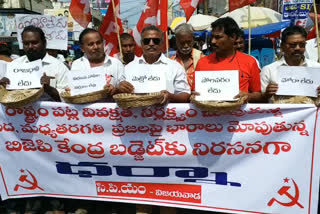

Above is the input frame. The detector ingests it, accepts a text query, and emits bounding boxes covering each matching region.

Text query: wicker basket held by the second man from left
[60,89,109,104]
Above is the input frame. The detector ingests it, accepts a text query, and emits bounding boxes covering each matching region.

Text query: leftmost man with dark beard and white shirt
[0,26,68,101]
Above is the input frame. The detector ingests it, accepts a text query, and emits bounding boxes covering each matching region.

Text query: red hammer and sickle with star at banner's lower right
[268,178,304,209]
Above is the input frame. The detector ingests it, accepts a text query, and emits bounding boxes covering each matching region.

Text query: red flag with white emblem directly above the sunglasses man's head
[132,0,168,56]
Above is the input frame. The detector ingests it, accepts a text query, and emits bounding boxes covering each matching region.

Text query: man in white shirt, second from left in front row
[71,28,124,95]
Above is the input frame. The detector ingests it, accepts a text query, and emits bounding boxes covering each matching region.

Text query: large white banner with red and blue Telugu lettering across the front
[0,102,320,214]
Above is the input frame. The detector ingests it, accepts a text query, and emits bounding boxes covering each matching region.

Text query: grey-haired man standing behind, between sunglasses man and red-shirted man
[170,23,204,87]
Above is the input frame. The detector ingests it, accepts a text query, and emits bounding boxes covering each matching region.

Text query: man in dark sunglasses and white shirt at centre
[118,25,190,104]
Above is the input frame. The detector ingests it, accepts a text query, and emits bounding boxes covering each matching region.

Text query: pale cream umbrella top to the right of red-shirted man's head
[221,6,282,28]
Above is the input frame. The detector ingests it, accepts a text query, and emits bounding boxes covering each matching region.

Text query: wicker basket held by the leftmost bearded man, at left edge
[0,86,44,108]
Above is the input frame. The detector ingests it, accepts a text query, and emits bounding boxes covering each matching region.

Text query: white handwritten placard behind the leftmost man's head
[15,14,68,50]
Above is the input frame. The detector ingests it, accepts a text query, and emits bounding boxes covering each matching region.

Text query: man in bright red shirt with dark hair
[192,17,261,102]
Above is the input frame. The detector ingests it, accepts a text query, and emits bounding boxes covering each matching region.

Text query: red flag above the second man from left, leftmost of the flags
[69,0,91,28]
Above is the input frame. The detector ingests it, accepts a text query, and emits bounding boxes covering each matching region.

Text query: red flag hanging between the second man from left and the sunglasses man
[99,0,123,56]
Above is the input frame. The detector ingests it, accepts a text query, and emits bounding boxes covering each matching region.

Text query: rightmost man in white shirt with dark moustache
[261,26,320,102]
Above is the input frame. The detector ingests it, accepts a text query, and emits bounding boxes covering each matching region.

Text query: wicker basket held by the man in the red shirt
[190,95,245,113]
